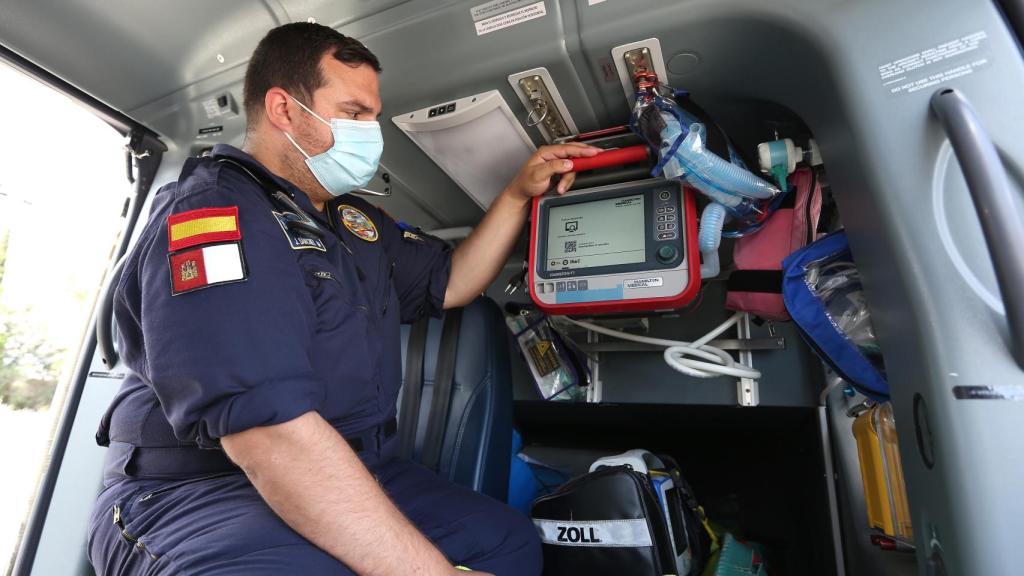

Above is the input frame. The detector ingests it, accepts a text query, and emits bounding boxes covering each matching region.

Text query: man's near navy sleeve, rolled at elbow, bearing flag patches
[138,184,325,447]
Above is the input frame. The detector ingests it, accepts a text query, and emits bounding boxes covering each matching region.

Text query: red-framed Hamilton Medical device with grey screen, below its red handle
[529,178,700,314]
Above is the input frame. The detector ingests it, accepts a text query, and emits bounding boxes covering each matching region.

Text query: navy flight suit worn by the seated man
[88,146,541,576]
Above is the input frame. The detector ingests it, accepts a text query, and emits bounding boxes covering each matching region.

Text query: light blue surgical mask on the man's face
[285,92,384,196]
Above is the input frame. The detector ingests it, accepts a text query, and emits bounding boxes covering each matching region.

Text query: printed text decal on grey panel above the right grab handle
[879,30,991,95]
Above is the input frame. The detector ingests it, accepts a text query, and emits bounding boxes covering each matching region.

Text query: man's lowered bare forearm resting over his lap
[221,412,453,575]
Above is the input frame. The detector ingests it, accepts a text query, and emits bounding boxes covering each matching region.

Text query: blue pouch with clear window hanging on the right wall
[782,231,889,402]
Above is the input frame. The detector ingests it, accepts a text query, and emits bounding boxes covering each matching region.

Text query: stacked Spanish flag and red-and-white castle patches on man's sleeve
[167,206,248,296]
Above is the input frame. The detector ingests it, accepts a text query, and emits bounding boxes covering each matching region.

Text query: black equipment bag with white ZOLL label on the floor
[530,450,702,576]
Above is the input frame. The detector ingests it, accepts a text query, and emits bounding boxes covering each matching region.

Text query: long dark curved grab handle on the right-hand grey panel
[932,88,1024,368]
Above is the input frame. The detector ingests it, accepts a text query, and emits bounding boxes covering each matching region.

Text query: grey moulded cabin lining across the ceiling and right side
[8,0,1024,574]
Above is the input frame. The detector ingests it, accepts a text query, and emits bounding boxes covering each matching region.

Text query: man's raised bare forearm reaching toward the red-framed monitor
[444,191,529,308]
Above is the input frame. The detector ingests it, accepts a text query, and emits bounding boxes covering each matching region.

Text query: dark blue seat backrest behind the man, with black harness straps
[398,297,512,501]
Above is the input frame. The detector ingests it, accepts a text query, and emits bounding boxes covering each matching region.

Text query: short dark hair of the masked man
[244,22,381,126]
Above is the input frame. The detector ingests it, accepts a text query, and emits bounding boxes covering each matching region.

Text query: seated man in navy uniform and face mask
[89,24,597,576]
